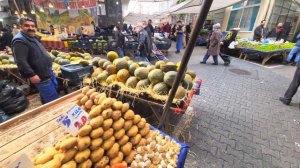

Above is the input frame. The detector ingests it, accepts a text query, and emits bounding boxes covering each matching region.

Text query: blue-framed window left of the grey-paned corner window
[227,0,261,31]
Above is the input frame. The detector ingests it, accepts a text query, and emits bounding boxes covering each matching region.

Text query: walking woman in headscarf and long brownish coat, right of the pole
[200,23,222,65]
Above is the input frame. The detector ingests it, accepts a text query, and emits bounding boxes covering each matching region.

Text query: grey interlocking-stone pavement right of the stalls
[166,47,300,168]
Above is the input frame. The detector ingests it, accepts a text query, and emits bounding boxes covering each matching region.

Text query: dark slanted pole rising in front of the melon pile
[158,0,213,128]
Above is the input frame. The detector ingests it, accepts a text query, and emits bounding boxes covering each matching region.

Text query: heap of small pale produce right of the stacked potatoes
[131,131,181,168]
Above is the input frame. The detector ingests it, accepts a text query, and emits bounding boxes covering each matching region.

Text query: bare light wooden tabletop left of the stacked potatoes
[0,90,81,168]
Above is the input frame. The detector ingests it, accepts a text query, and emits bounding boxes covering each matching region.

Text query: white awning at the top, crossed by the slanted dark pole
[170,0,241,14]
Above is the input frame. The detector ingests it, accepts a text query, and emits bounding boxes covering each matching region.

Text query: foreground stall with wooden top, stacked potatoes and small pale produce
[0,87,189,168]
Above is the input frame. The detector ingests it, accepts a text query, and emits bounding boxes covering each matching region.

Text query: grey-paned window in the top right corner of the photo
[268,0,300,34]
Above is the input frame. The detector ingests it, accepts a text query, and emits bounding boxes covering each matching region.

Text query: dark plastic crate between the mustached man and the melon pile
[60,64,94,85]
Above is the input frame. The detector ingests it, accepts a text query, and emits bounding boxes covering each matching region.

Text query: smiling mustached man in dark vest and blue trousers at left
[12,17,58,103]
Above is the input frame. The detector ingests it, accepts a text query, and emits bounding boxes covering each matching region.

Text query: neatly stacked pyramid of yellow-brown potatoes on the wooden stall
[34,87,150,168]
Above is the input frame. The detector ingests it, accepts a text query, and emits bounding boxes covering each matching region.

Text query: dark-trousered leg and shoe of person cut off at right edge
[279,61,300,108]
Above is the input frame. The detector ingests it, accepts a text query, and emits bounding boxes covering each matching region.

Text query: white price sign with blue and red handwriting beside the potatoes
[57,105,89,136]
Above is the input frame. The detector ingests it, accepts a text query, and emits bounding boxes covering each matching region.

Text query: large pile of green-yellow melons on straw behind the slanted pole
[91,51,196,99]
